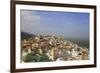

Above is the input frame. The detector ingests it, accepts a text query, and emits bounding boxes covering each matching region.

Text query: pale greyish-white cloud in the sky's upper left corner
[21,10,41,32]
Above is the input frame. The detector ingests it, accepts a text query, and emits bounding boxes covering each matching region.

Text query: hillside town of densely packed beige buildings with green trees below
[21,35,90,63]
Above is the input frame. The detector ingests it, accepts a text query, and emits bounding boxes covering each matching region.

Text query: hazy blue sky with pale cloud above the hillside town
[21,10,89,38]
